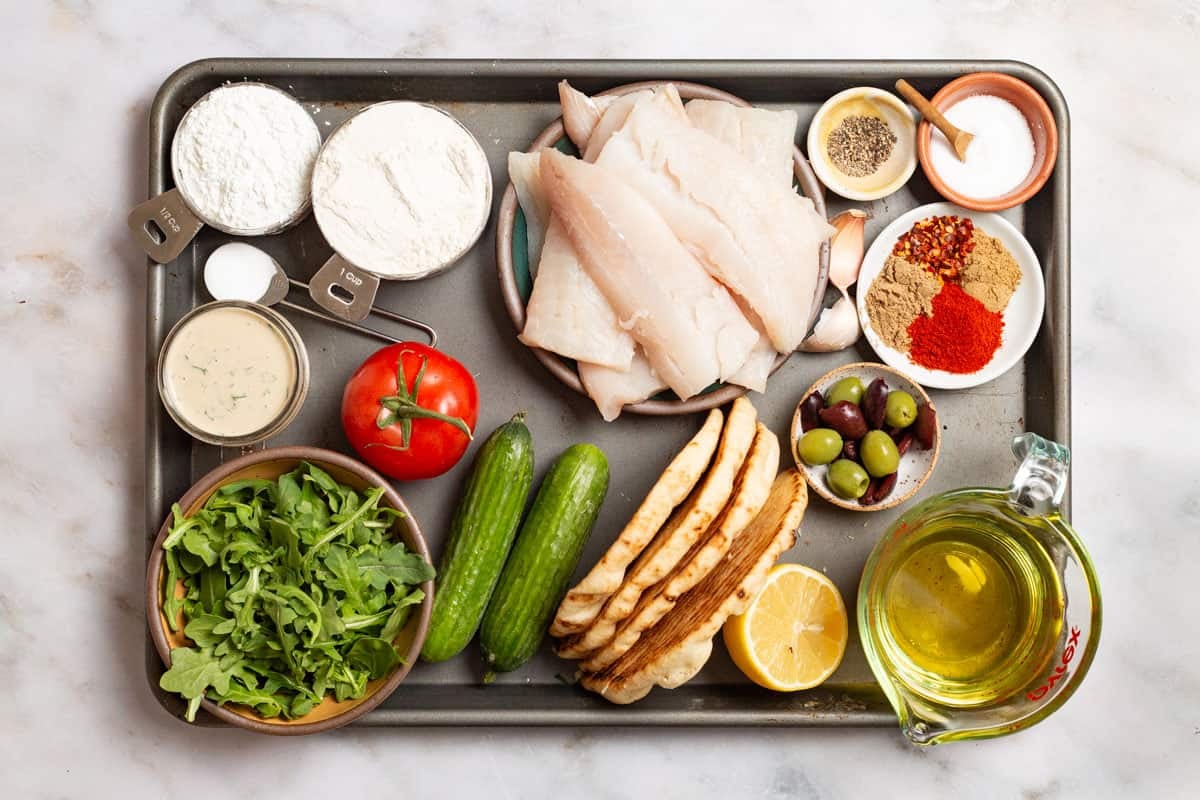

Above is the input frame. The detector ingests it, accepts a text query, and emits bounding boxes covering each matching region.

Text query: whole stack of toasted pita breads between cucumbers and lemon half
[550,398,808,703]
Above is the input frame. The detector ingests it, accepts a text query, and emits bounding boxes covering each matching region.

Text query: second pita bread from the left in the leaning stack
[558,397,758,658]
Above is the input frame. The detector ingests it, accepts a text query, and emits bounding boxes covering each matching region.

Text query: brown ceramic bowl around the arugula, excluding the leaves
[146,447,433,736]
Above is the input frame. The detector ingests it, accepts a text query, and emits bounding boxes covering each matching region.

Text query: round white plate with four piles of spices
[858,203,1045,389]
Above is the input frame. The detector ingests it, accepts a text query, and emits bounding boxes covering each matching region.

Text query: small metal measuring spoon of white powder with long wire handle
[204,242,438,347]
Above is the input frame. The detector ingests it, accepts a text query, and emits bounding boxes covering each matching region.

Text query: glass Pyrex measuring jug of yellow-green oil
[858,433,1100,745]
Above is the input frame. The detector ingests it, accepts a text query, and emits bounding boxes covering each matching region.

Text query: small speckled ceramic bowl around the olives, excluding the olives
[790,361,942,511]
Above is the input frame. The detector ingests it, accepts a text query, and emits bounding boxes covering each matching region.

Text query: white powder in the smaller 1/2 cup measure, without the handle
[172,84,320,233]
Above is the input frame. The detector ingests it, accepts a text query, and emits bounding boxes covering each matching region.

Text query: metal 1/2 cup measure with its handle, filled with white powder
[128,82,320,264]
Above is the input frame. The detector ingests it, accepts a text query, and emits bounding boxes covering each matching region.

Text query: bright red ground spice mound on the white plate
[908,283,1004,373]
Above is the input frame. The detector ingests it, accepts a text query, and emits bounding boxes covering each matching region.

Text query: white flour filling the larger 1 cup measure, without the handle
[312,102,491,278]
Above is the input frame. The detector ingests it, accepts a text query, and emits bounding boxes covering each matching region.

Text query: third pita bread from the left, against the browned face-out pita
[580,422,779,672]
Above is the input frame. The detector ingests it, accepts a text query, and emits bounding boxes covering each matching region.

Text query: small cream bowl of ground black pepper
[808,86,917,200]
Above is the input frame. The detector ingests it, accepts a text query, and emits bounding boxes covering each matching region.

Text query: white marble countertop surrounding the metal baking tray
[0,0,1200,799]
